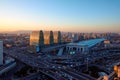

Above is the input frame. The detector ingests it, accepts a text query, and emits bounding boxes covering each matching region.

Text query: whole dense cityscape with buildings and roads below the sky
[0,31,120,80]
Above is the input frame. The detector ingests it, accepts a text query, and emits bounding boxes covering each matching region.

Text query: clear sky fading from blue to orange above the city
[0,0,120,32]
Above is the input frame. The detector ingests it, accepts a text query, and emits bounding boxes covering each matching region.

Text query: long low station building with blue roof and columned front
[66,38,105,54]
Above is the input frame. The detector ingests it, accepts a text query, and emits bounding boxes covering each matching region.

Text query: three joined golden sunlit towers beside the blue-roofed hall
[30,30,61,52]
